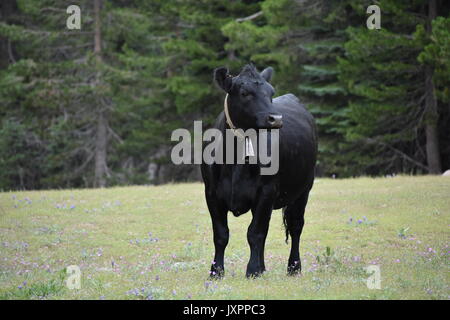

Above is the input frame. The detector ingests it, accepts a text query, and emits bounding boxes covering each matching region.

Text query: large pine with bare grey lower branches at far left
[0,0,170,188]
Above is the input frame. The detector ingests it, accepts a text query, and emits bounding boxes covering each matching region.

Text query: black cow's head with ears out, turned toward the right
[214,65,283,130]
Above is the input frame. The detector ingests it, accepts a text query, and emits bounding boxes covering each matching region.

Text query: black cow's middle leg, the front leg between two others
[246,185,274,278]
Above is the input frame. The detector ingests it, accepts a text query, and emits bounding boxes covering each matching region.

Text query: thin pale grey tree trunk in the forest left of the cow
[94,0,108,188]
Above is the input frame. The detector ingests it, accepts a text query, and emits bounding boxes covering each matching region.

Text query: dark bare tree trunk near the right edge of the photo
[425,0,442,174]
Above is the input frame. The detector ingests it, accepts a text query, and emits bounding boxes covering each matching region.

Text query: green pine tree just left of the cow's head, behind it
[122,0,268,183]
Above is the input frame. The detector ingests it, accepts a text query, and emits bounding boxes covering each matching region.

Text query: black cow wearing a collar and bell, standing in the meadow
[201,65,317,278]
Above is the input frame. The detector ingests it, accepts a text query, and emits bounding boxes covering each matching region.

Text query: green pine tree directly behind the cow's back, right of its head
[222,0,362,176]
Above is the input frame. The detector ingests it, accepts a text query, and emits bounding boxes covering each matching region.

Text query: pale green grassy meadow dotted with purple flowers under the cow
[0,176,450,299]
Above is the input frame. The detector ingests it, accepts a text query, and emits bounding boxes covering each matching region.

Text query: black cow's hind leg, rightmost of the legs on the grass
[283,190,309,275]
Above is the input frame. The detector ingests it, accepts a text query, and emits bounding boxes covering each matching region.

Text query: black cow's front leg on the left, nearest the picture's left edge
[206,191,230,279]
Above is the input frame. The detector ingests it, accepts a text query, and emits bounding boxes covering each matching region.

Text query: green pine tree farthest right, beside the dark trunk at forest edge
[339,0,448,174]
